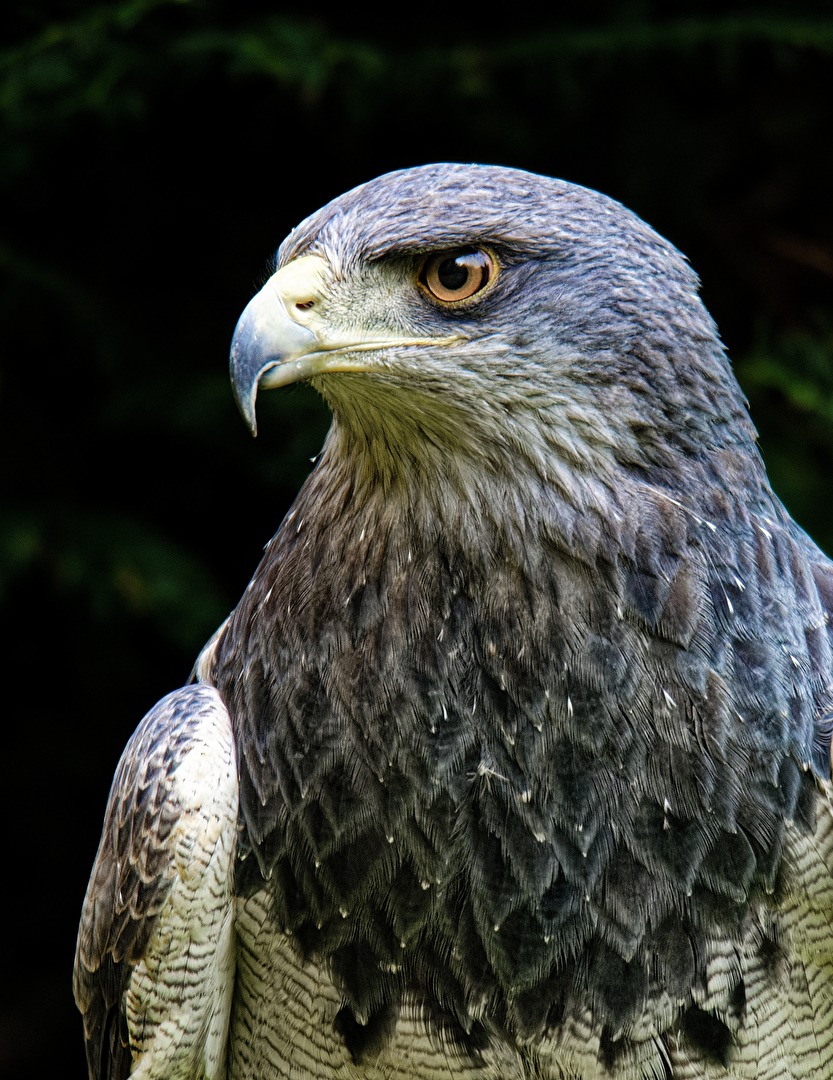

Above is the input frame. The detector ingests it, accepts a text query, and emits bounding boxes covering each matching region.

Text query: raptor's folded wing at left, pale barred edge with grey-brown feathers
[73,685,238,1080]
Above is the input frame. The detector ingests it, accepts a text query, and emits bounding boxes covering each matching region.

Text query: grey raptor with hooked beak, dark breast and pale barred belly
[75,164,833,1080]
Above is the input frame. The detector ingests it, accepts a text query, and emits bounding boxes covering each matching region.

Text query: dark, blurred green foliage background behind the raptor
[0,0,833,1080]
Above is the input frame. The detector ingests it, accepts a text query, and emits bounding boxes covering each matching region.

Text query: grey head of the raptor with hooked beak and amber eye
[231,164,755,494]
